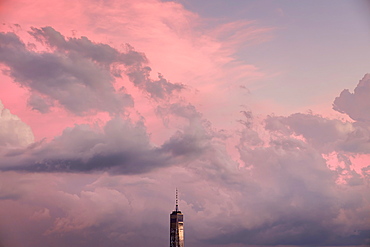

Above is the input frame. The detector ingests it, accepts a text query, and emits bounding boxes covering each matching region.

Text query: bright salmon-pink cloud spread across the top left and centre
[4,0,270,143]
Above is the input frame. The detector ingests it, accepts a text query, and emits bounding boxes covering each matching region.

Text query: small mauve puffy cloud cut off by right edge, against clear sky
[333,74,370,122]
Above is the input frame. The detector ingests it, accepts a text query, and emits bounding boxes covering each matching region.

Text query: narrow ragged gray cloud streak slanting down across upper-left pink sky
[30,27,185,99]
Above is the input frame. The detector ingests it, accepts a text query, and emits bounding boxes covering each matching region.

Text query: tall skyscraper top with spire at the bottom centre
[170,189,184,247]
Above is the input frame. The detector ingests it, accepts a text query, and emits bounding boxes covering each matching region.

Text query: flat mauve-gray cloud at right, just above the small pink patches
[265,113,370,153]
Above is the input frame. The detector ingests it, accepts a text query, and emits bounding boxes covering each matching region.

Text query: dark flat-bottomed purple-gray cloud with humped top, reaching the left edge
[1,106,212,174]
